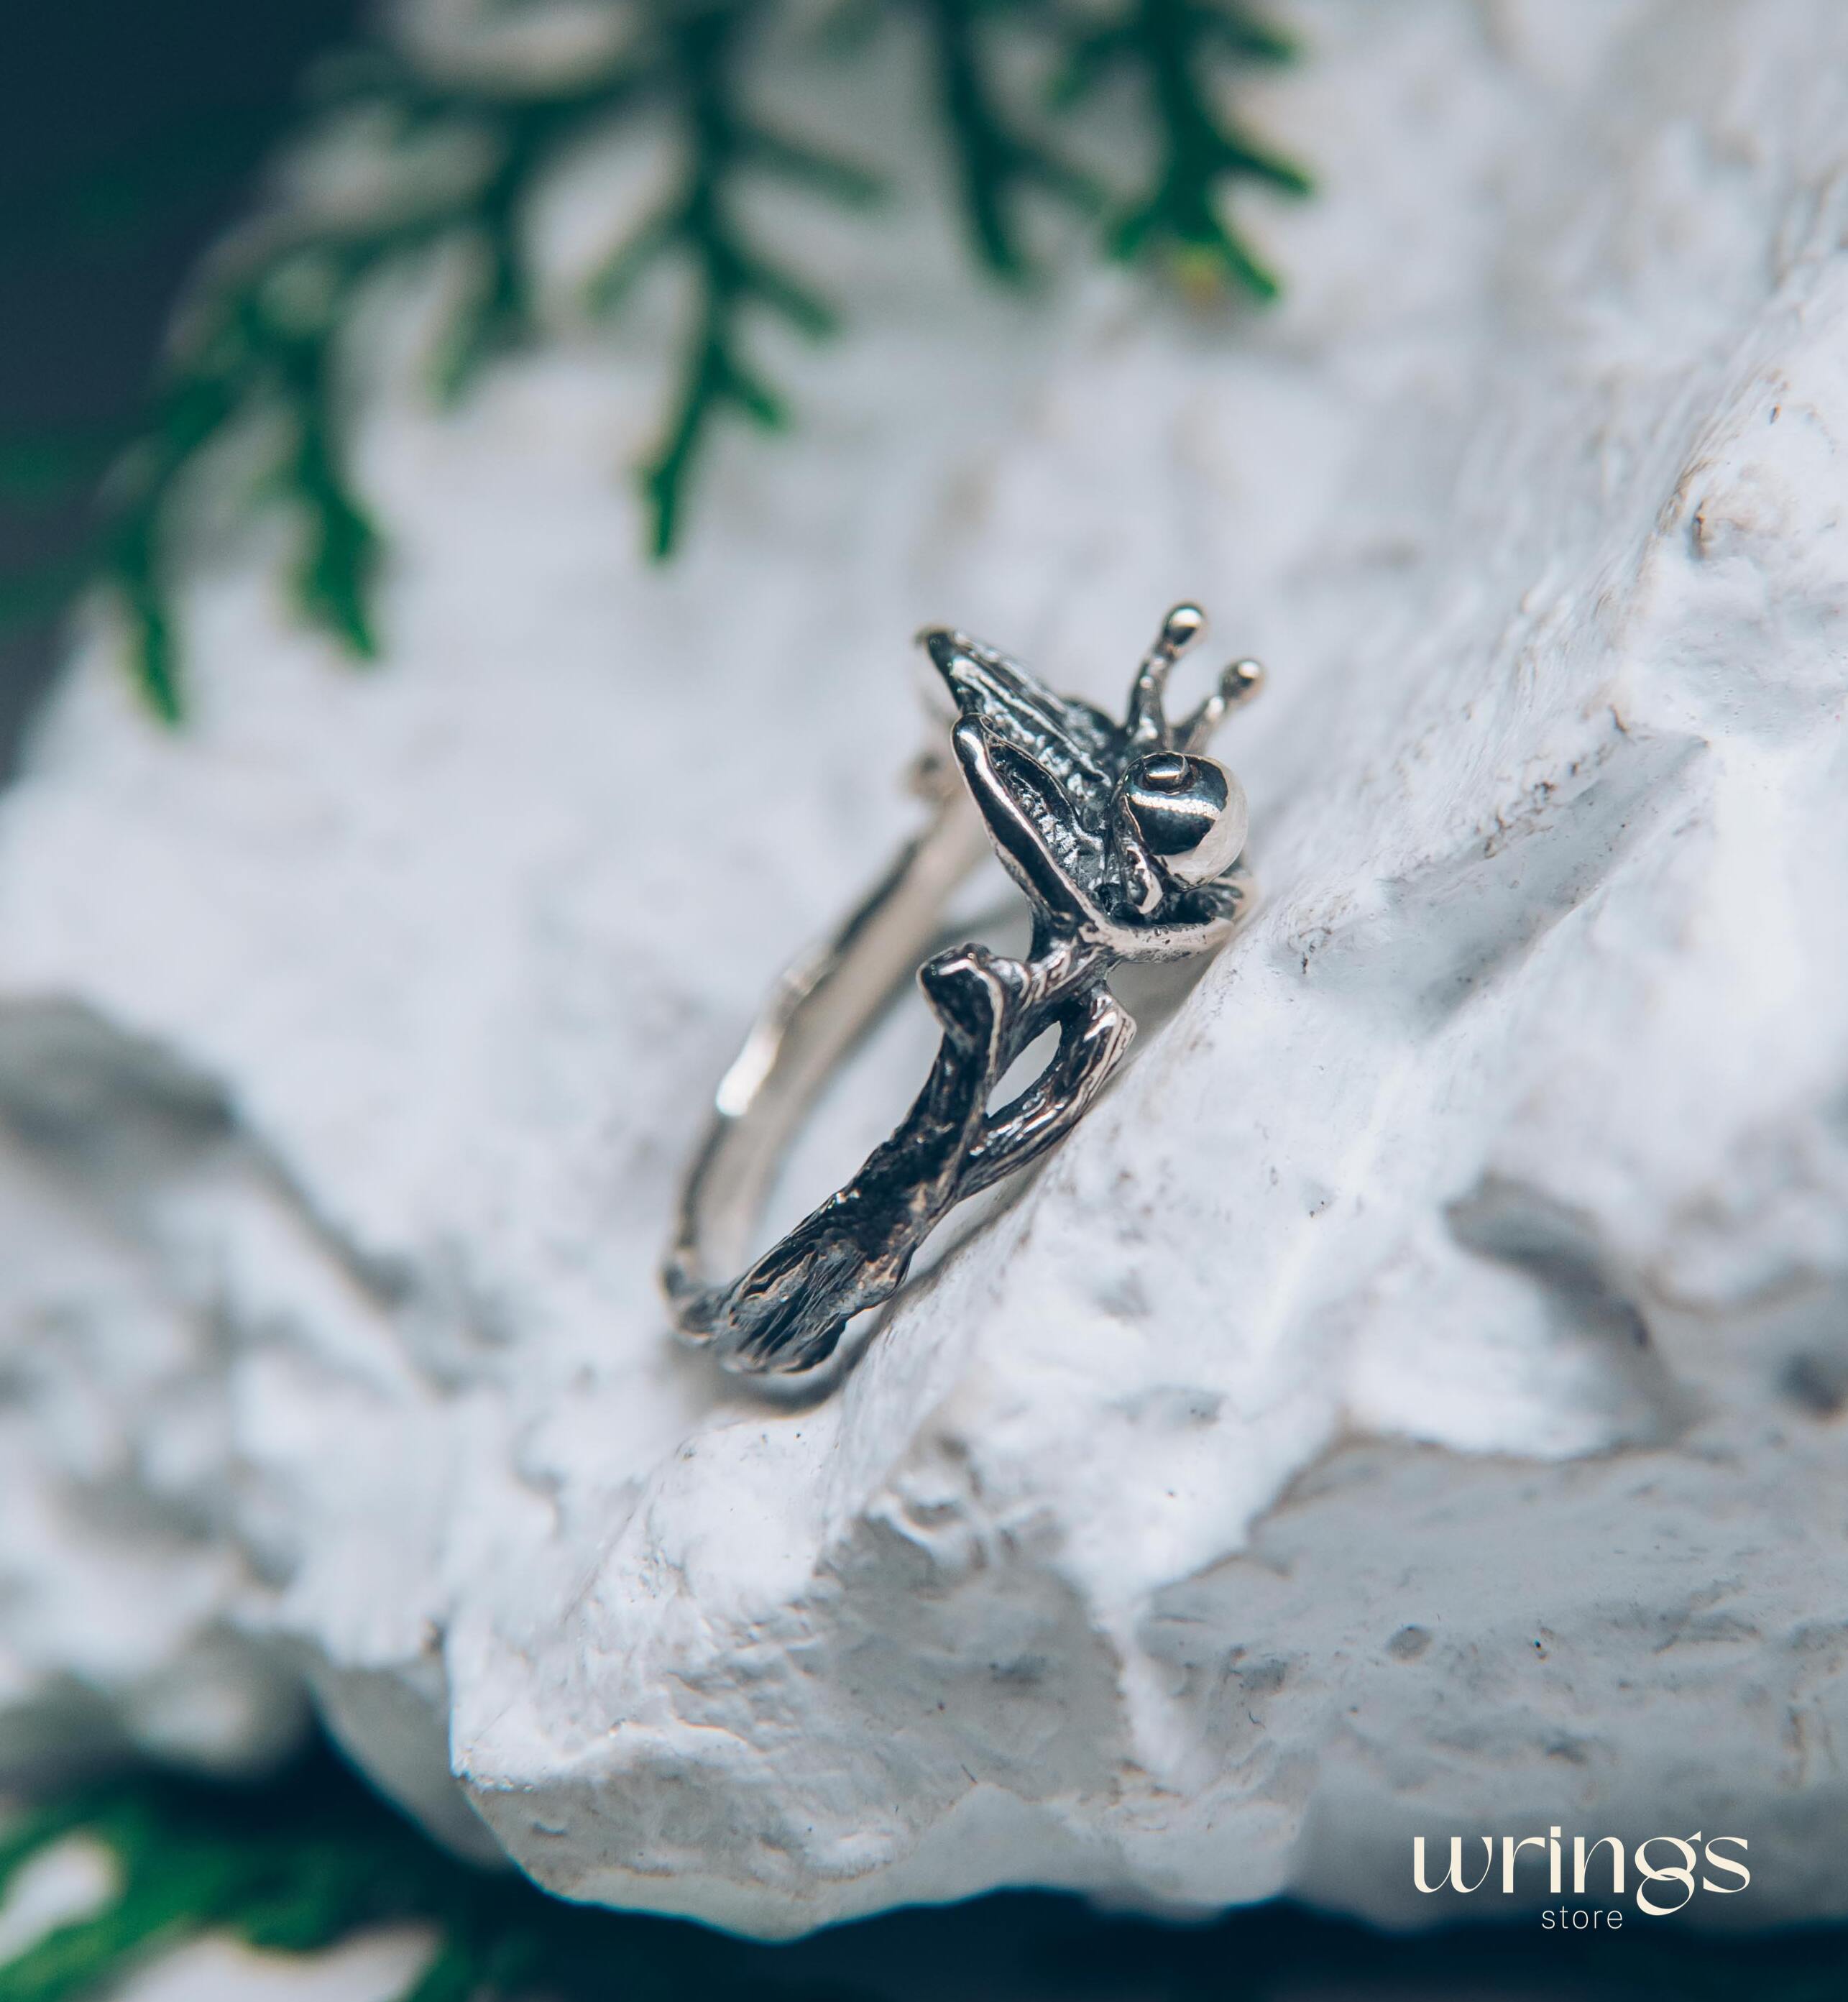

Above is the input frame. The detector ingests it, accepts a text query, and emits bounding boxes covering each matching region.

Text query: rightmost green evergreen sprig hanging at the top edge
[1057,0,1310,298]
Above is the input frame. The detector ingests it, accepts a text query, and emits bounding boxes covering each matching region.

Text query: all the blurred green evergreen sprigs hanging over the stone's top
[0,0,1307,722]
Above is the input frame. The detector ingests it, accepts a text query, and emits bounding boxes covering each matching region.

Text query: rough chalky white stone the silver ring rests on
[0,0,1848,1934]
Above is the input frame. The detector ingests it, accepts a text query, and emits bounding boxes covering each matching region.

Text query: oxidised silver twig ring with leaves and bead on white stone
[661,605,1264,1374]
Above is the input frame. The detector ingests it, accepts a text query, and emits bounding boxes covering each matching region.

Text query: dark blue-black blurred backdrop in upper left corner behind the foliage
[0,0,369,771]
